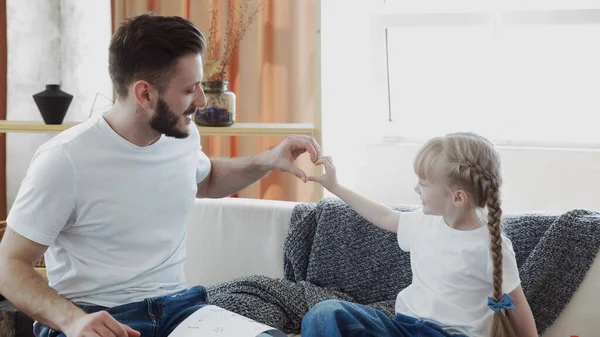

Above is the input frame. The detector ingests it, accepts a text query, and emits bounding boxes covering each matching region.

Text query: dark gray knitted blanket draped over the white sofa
[208,199,600,333]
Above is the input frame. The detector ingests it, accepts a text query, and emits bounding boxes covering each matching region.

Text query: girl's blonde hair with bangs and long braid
[414,133,516,337]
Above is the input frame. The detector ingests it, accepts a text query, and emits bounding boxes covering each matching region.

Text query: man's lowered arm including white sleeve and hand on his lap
[0,147,140,337]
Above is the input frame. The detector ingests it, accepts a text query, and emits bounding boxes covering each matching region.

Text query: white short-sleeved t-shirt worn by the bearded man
[7,117,211,307]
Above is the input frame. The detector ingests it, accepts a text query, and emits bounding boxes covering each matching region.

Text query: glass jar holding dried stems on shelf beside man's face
[194,82,235,126]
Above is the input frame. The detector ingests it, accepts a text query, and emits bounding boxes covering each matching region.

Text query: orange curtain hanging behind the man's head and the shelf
[112,0,314,201]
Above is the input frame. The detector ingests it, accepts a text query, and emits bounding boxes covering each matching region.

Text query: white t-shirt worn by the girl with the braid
[396,210,521,337]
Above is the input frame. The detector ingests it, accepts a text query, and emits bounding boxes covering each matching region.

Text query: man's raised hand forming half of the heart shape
[271,136,321,182]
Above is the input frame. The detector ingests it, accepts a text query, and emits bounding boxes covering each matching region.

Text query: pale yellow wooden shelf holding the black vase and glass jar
[0,120,315,136]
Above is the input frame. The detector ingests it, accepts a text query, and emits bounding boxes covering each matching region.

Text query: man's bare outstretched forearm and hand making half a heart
[197,136,320,198]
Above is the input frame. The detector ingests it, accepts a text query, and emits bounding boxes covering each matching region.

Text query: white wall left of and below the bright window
[321,0,600,212]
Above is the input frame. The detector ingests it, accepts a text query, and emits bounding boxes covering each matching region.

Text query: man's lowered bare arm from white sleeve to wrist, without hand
[0,227,85,331]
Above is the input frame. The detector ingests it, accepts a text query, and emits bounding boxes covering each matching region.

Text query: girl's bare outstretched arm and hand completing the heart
[308,157,400,233]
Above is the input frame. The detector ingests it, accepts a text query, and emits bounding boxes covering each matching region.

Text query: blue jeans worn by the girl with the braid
[302,300,462,337]
